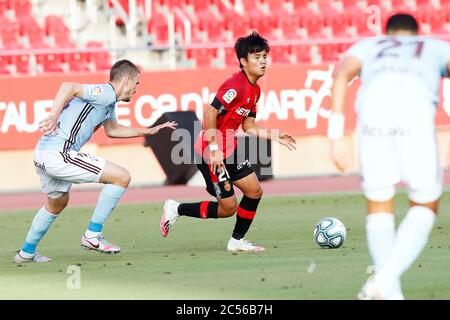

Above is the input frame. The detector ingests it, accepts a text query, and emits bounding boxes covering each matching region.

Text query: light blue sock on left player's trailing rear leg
[22,206,58,255]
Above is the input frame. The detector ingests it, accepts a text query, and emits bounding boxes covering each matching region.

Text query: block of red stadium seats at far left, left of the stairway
[0,0,111,75]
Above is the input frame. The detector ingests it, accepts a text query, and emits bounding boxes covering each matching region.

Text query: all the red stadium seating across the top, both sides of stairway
[0,0,450,75]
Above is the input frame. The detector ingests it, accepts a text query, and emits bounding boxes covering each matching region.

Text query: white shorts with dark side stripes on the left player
[34,150,106,199]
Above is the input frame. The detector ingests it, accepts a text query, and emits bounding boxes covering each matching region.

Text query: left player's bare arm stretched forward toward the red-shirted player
[103,119,178,138]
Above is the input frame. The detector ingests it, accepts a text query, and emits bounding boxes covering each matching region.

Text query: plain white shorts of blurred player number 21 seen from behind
[358,124,443,203]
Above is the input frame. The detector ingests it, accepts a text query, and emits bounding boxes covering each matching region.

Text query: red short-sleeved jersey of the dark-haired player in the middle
[194,71,261,158]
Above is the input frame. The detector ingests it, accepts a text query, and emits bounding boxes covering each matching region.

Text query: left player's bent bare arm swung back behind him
[39,82,83,135]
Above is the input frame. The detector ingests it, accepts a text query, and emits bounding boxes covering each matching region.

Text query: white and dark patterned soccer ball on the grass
[314,217,347,249]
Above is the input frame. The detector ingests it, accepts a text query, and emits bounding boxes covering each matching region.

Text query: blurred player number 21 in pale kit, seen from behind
[328,14,450,299]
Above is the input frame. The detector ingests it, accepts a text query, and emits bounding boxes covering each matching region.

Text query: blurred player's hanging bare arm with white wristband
[327,57,361,172]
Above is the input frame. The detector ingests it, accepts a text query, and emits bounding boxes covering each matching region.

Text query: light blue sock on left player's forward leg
[86,184,127,238]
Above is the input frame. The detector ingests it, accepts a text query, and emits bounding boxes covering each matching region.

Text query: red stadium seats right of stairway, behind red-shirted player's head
[142,0,450,65]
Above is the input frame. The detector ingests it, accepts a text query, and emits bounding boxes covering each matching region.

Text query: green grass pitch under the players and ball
[0,192,450,300]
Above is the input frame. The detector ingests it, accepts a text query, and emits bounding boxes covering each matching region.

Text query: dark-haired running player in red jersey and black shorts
[160,32,295,252]
